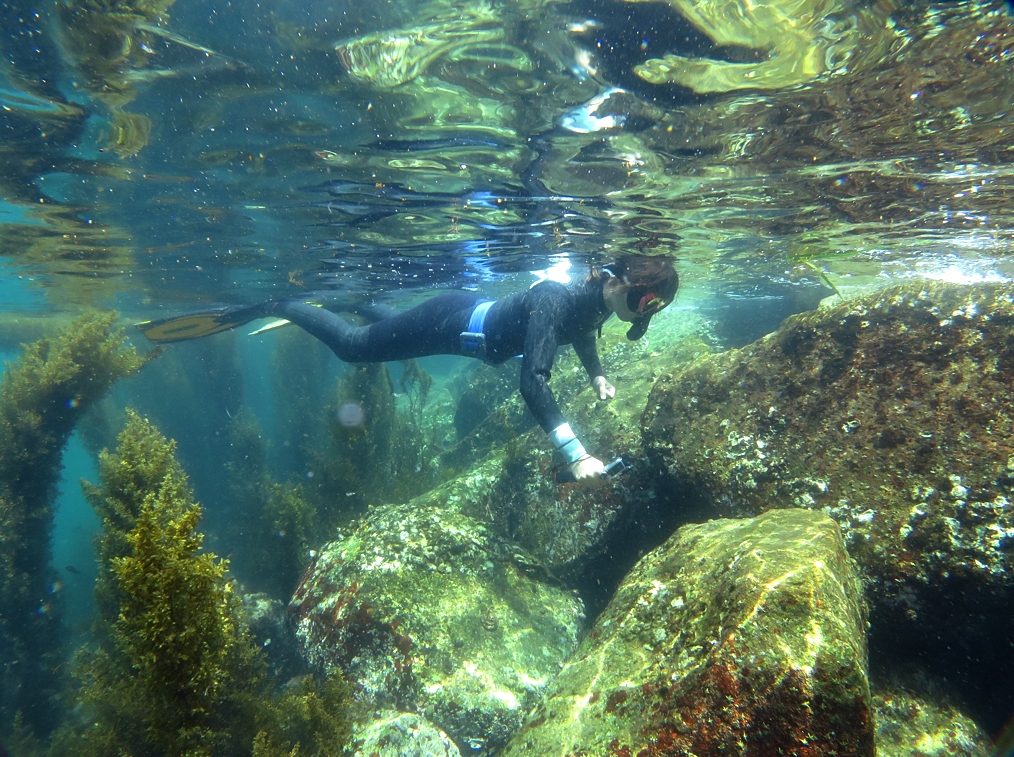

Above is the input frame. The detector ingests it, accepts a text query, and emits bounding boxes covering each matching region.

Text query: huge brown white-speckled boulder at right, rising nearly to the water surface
[643,284,1014,725]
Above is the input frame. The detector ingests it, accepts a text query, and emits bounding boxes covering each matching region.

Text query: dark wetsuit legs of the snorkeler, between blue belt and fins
[271,292,480,363]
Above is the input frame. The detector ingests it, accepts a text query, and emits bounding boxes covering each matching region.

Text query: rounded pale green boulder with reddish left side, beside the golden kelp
[290,502,584,752]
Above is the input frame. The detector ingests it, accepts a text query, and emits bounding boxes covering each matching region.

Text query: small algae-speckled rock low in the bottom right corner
[873,691,992,757]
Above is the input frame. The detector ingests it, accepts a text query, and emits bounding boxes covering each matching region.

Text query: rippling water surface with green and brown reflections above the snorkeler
[0,0,1014,315]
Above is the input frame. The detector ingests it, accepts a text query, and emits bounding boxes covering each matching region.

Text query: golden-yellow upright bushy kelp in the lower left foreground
[67,411,348,757]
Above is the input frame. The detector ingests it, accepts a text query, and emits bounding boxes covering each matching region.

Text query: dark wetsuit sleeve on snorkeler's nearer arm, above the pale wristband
[521,293,568,434]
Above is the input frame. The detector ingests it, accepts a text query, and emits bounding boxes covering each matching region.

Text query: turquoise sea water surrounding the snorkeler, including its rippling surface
[0,0,1014,757]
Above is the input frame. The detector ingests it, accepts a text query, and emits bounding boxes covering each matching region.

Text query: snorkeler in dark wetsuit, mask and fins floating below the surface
[138,255,679,484]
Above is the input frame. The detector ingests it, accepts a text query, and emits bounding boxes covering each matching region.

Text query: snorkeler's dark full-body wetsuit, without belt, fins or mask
[269,279,610,434]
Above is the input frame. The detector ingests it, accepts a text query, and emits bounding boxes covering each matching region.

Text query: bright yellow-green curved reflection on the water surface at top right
[628,0,888,92]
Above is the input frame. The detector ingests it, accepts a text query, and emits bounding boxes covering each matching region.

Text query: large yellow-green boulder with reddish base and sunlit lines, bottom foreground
[505,510,873,757]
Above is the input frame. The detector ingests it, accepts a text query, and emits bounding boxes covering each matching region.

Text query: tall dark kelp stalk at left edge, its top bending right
[0,312,145,733]
